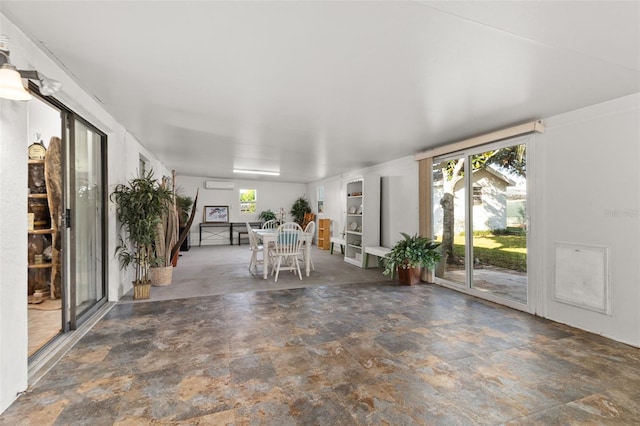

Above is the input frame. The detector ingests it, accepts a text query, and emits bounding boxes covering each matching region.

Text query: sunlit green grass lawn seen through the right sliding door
[453,235,527,272]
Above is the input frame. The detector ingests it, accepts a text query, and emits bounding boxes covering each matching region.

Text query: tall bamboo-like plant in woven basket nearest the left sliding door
[110,170,172,299]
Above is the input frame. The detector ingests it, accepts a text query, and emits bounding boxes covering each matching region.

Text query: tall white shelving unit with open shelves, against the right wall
[344,176,380,268]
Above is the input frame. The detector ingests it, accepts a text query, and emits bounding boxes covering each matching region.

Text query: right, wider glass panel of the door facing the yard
[468,144,527,304]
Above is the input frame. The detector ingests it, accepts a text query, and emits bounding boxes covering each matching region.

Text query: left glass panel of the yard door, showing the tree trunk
[433,157,467,285]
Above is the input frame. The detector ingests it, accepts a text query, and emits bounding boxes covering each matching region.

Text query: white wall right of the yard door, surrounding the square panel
[531,94,640,346]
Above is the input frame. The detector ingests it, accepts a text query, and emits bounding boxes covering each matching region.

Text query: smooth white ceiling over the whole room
[0,0,640,183]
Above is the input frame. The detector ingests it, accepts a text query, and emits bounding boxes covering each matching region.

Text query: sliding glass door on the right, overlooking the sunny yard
[432,140,527,305]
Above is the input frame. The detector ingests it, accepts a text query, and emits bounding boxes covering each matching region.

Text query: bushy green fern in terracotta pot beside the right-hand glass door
[383,232,440,285]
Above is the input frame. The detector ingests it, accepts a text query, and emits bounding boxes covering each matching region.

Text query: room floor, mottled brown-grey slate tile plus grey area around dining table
[0,248,640,425]
